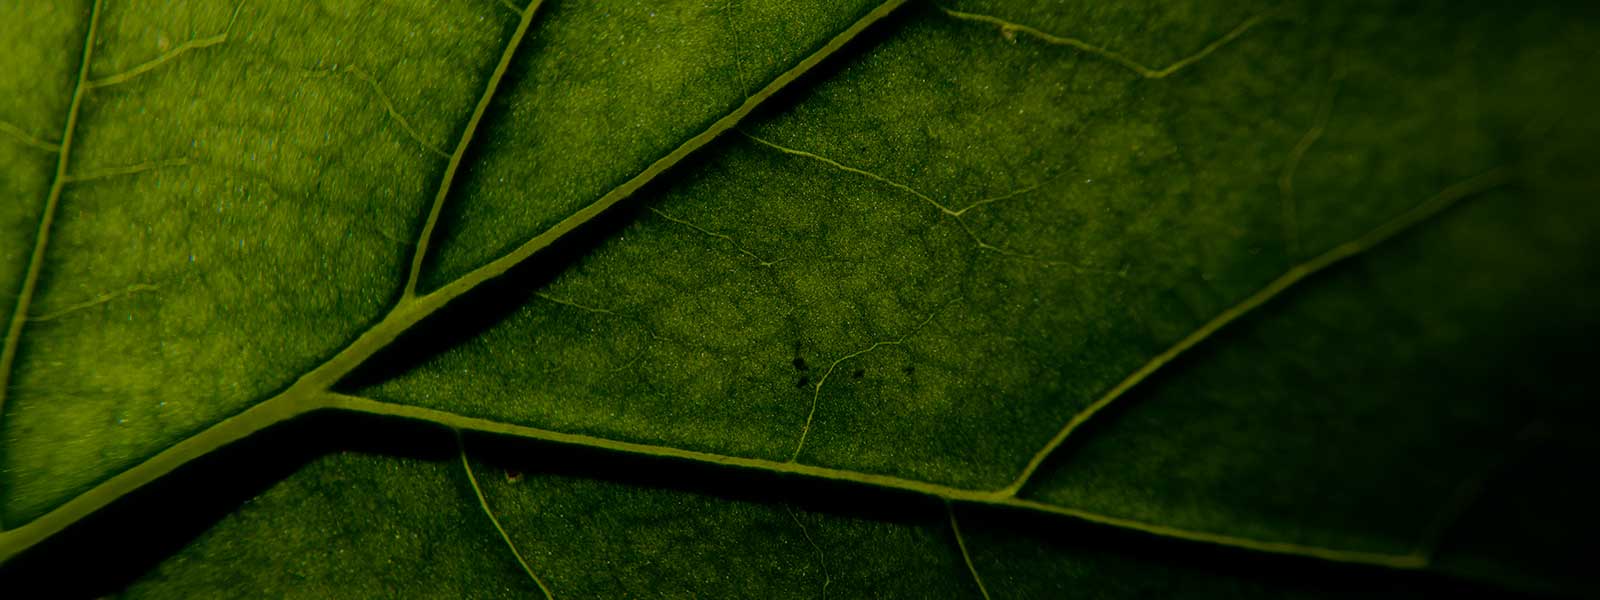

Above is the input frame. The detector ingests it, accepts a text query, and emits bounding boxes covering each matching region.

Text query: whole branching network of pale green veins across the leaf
[0,0,1507,582]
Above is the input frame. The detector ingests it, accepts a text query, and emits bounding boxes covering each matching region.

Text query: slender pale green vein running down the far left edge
[0,0,104,534]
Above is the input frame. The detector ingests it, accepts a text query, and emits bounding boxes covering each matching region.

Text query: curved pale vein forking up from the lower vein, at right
[1002,168,1512,496]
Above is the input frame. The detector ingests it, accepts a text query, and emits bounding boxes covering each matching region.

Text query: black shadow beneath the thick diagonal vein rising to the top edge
[338,1,933,392]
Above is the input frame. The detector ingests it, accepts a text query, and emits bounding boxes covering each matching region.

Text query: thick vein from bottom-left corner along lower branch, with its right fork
[0,160,1512,568]
